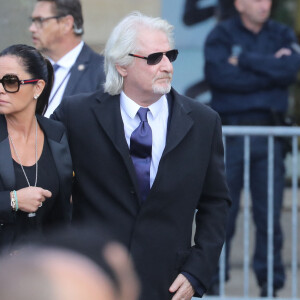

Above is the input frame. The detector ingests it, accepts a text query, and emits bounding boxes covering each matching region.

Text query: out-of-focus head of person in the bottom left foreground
[0,224,140,300]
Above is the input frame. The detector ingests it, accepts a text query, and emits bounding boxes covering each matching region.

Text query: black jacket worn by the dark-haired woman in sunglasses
[0,115,72,248]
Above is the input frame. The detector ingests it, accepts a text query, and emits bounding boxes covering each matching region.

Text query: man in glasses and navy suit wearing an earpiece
[29,0,105,117]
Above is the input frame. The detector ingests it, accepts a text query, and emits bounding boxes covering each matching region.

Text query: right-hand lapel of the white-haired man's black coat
[162,89,194,157]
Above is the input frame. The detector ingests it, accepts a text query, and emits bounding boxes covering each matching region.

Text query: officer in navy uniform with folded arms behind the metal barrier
[205,0,300,296]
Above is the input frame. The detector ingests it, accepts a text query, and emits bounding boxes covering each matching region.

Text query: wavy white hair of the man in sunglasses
[104,11,174,95]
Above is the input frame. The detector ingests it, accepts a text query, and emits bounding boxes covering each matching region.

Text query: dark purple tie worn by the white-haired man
[130,107,152,201]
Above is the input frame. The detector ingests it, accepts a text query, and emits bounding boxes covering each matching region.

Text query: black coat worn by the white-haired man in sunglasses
[52,90,230,300]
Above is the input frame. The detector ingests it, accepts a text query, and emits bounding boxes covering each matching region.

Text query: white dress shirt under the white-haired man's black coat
[120,92,169,187]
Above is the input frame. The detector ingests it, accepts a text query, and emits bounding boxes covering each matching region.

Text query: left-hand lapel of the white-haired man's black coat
[92,94,139,197]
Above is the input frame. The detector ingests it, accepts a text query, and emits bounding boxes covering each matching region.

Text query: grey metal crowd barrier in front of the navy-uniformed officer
[198,126,300,300]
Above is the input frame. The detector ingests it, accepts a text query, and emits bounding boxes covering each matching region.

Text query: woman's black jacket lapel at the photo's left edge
[0,115,15,190]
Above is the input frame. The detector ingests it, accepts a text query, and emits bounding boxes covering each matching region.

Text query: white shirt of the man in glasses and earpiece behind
[45,41,84,118]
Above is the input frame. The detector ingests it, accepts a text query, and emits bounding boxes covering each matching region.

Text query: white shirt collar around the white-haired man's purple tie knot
[120,91,168,119]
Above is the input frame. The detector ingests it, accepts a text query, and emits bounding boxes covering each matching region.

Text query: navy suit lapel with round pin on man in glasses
[63,44,89,98]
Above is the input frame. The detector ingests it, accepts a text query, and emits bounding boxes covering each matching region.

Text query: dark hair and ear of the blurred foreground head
[22,226,140,300]
